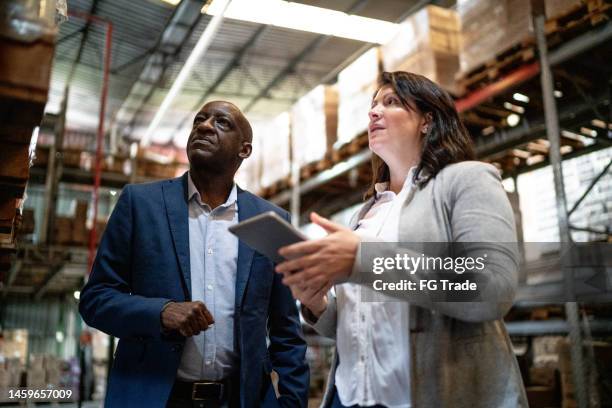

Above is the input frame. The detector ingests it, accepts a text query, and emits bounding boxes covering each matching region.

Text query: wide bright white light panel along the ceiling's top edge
[202,0,399,44]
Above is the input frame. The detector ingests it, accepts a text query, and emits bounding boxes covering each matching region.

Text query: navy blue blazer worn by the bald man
[79,173,309,408]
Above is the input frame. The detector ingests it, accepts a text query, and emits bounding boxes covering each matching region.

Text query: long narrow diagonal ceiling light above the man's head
[140,0,232,146]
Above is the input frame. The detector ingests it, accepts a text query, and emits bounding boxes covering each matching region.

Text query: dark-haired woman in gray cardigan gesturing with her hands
[277,72,527,408]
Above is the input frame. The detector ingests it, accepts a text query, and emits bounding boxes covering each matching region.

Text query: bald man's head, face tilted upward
[187,101,251,169]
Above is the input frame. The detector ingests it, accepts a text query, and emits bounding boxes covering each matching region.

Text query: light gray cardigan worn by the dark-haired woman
[304,161,528,408]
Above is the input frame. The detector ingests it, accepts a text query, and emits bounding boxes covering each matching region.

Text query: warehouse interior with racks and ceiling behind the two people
[0,0,612,408]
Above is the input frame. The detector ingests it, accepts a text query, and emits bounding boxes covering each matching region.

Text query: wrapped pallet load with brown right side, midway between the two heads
[291,85,338,167]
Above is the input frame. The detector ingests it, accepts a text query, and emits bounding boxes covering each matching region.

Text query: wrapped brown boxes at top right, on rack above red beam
[457,0,582,74]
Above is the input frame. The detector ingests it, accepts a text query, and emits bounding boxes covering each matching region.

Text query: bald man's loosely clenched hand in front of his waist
[161,302,215,337]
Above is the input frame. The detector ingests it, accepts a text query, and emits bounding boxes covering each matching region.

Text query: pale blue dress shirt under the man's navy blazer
[177,174,238,381]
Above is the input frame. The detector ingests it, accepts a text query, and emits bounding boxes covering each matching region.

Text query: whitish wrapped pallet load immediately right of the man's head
[253,112,291,187]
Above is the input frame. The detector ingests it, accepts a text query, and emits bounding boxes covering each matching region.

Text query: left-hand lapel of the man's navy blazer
[162,173,191,300]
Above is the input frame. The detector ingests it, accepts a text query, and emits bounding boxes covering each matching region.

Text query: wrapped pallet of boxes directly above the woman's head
[381,6,461,95]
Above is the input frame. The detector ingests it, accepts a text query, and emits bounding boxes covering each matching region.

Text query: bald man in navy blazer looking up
[79,101,309,408]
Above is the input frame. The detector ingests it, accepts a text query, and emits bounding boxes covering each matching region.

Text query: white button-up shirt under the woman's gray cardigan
[335,168,414,408]
